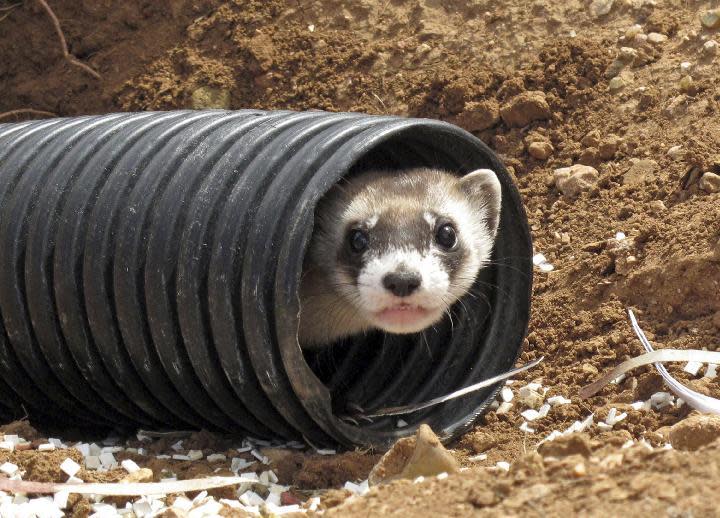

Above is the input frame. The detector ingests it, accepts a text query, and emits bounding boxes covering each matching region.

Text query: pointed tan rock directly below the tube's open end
[368,425,459,486]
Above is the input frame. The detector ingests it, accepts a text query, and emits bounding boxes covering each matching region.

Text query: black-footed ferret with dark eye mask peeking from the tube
[298,168,501,349]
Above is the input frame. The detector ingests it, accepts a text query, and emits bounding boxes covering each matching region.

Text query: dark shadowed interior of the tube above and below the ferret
[305,139,497,430]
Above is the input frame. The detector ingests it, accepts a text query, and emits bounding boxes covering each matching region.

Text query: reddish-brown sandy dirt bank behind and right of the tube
[0,0,720,516]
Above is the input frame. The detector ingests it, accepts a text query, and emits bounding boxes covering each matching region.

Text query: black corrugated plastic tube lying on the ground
[0,110,532,446]
